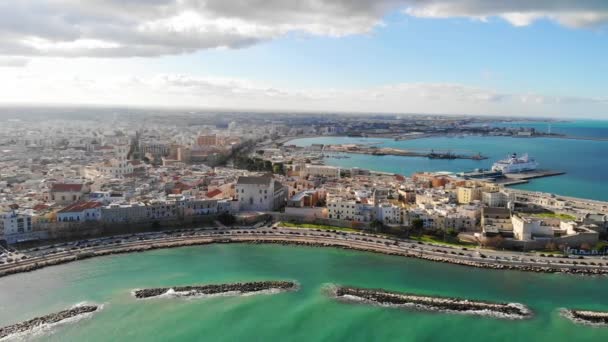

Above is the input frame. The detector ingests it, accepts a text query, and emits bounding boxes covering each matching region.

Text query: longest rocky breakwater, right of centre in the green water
[334,286,532,319]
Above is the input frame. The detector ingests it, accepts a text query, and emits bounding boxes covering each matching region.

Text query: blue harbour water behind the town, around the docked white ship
[290,132,608,200]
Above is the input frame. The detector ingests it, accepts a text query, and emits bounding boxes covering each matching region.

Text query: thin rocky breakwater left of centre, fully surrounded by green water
[134,281,297,299]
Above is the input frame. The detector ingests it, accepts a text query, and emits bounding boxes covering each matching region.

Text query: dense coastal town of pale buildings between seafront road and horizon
[0,109,608,264]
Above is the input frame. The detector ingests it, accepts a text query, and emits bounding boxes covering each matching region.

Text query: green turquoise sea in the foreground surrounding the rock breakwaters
[0,245,608,342]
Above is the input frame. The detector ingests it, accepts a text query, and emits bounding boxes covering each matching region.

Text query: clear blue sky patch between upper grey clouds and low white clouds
[160,14,608,96]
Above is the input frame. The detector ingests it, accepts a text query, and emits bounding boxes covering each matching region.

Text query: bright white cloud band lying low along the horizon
[0,73,608,117]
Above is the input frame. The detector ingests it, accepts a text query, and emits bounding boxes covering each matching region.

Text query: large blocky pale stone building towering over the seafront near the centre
[236,176,286,211]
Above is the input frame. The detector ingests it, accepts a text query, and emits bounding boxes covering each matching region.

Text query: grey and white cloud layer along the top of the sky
[0,0,608,57]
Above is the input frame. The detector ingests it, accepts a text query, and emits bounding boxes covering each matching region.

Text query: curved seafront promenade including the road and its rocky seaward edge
[0,227,608,277]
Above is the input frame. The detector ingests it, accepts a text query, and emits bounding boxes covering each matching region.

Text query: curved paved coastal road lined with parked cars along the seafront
[0,226,608,271]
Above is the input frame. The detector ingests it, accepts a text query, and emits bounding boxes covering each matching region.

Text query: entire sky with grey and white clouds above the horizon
[0,0,608,119]
